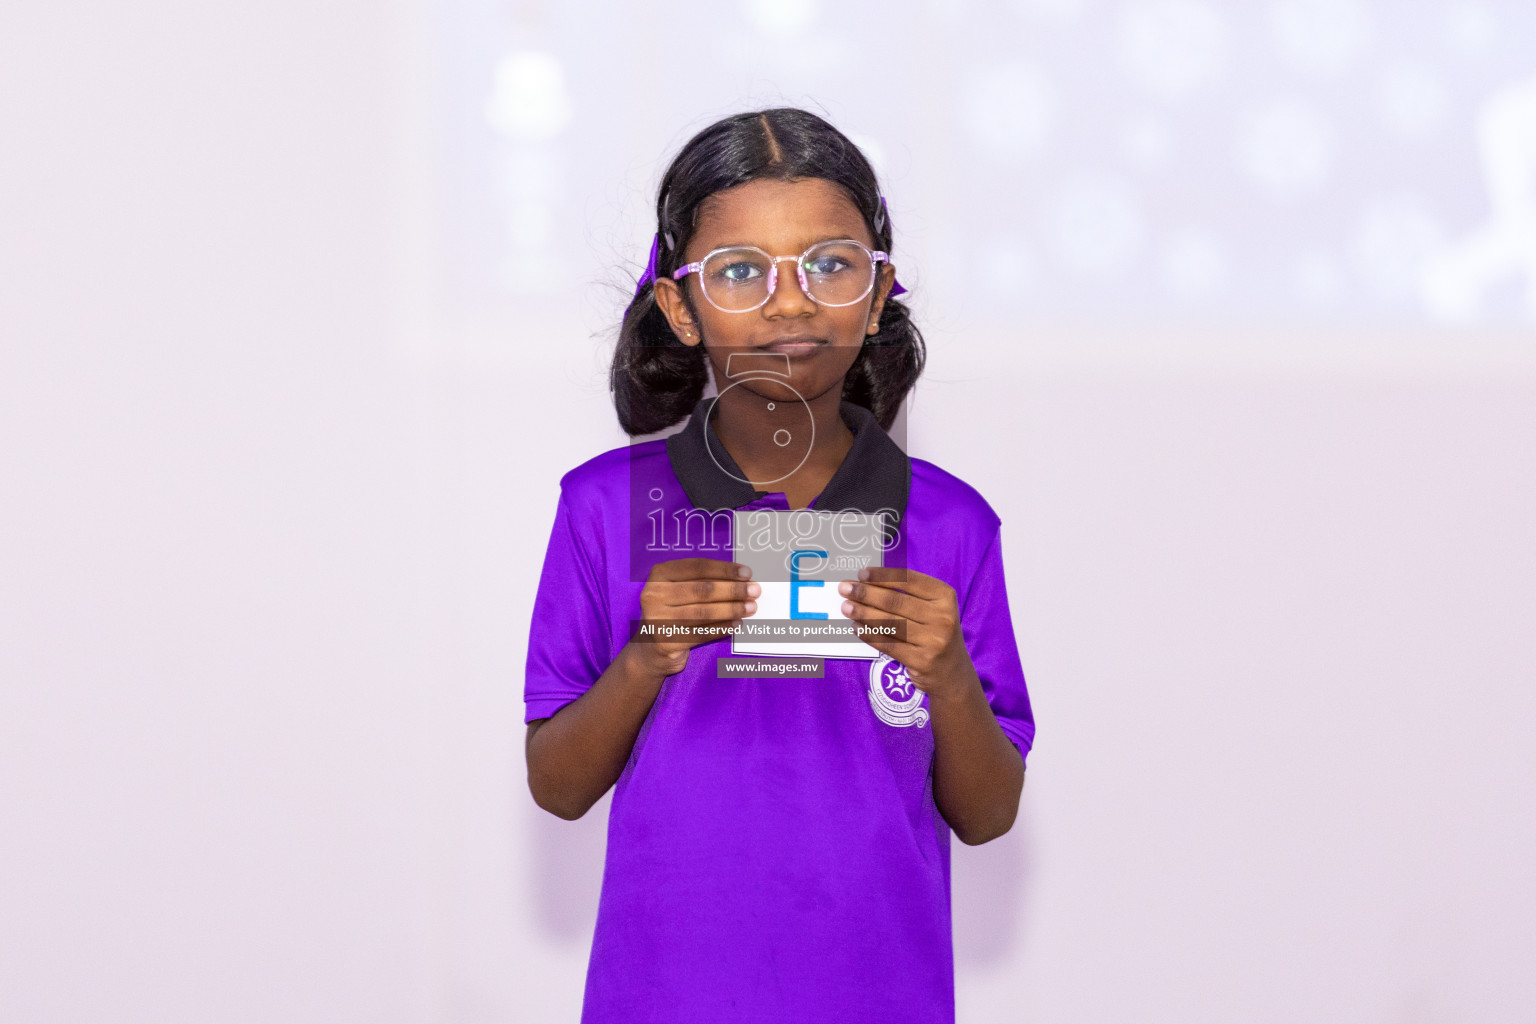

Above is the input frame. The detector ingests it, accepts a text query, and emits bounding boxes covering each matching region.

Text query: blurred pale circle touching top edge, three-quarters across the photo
[1120,0,1227,100]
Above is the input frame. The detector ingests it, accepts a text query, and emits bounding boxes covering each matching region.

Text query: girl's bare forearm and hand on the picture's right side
[840,568,1025,846]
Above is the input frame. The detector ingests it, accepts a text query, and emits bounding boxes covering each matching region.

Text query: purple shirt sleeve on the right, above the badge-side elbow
[960,531,1035,761]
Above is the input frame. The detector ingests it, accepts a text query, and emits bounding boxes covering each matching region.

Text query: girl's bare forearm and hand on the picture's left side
[525,559,762,821]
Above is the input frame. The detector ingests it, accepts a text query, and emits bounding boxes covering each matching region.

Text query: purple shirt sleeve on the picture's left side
[522,491,613,722]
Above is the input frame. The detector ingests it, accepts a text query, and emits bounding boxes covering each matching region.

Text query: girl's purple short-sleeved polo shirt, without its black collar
[524,399,1035,1024]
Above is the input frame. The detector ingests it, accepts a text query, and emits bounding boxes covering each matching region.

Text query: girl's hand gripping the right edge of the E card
[837,567,978,700]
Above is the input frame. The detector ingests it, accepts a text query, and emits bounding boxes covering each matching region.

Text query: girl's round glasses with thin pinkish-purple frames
[673,238,891,313]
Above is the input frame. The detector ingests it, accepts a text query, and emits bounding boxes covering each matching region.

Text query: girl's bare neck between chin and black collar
[713,387,854,508]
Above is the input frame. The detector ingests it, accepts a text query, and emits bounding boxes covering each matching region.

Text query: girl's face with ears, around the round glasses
[656,178,895,402]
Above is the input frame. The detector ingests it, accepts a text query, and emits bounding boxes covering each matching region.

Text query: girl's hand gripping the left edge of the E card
[631,559,762,676]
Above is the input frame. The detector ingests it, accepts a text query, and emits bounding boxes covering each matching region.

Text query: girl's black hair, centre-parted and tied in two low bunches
[608,107,926,436]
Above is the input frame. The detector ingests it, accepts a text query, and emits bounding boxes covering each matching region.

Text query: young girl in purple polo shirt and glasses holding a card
[525,109,1034,1024]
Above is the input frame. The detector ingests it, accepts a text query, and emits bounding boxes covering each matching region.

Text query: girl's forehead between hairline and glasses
[688,178,872,249]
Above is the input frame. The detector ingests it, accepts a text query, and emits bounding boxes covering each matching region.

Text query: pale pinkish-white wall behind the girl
[0,0,1536,1024]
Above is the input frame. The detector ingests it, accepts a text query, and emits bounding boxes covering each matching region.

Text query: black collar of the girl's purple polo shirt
[667,398,912,525]
